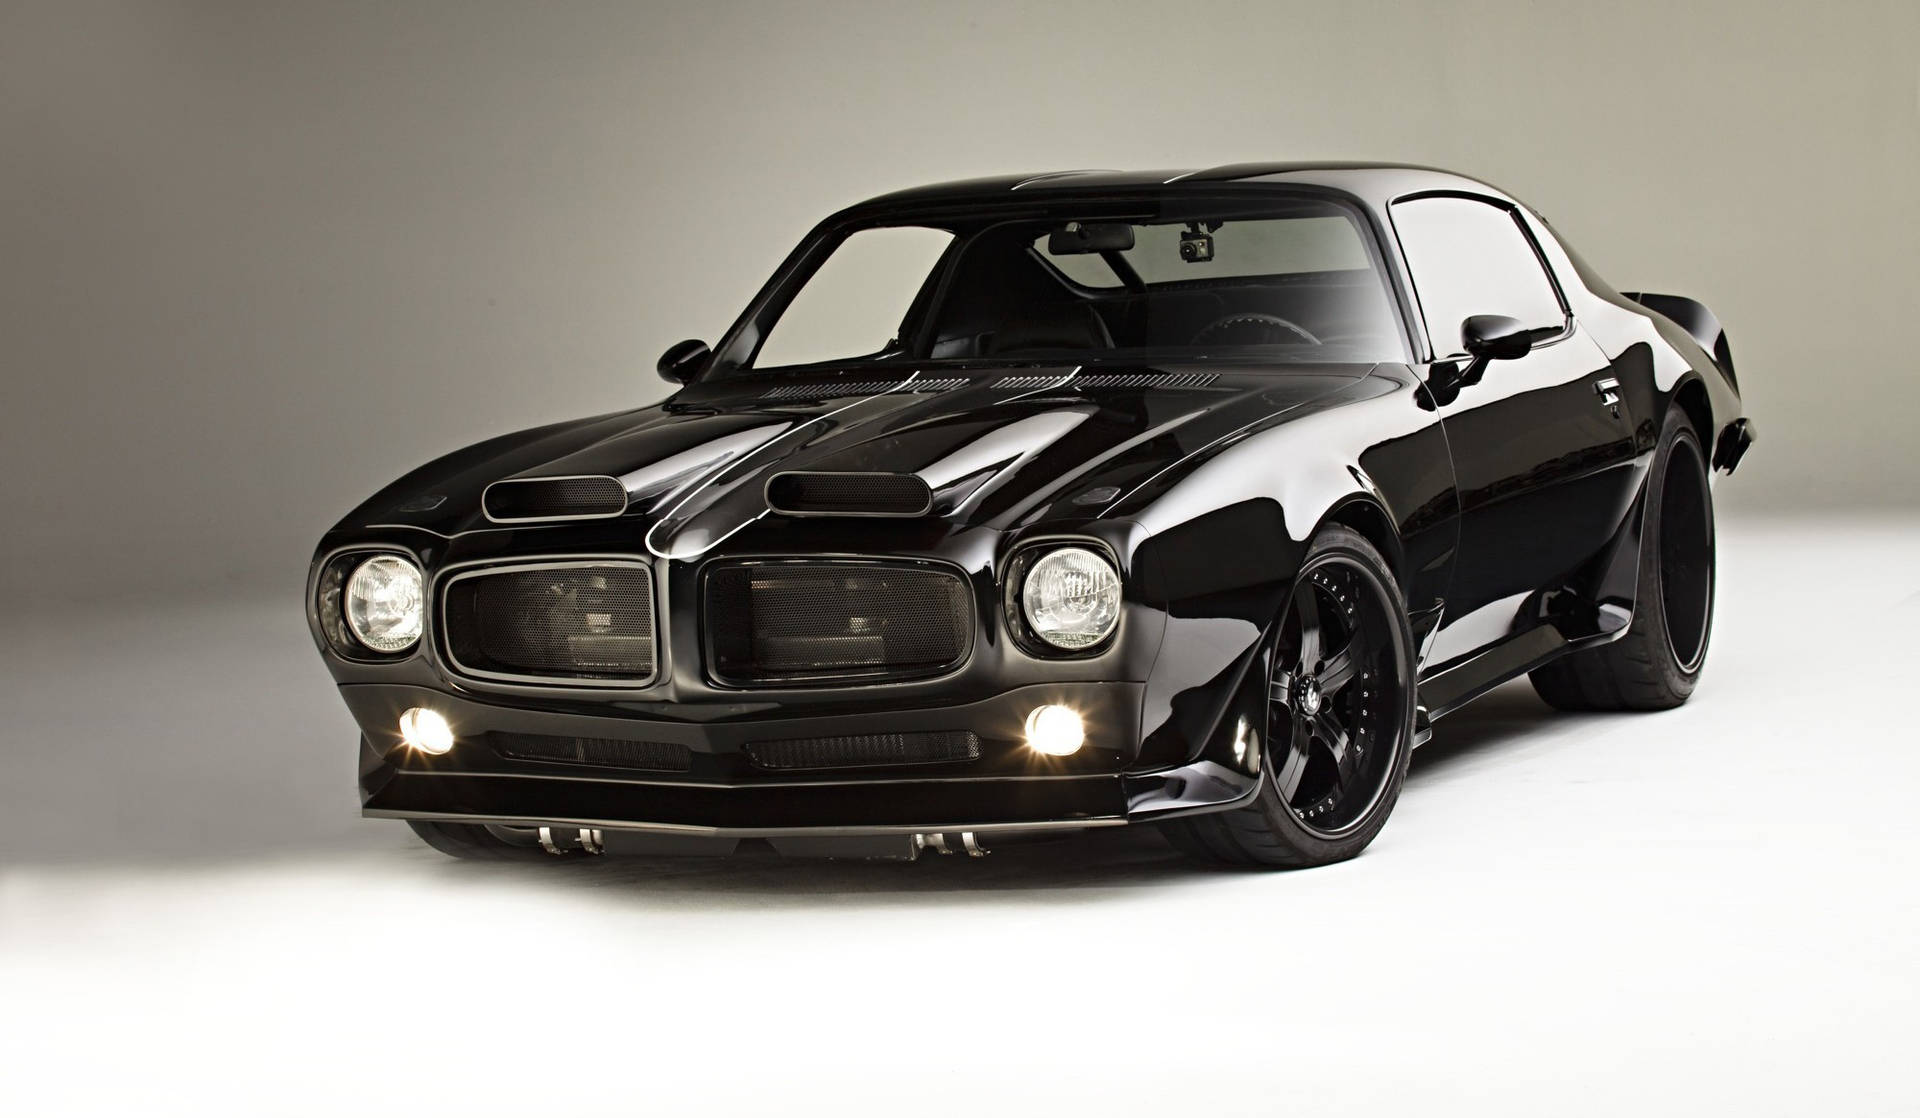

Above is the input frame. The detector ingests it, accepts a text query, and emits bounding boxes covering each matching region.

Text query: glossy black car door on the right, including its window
[1390,194,1636,668]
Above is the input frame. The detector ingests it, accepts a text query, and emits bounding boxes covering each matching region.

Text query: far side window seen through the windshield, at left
[753,225,952,369]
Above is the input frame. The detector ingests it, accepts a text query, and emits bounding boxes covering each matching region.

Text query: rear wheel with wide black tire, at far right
[1530,407,1715,711]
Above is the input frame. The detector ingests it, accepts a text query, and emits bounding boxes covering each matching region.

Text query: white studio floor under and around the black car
[0,519,1920,1118]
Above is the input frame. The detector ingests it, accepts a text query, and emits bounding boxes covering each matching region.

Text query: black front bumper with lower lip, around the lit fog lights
[340,682,1254,838]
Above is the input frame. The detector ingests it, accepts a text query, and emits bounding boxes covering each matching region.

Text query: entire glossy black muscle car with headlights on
[307,163,1753,866]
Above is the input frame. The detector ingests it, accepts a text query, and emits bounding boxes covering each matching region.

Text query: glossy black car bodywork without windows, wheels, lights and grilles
[307,165,1751,864]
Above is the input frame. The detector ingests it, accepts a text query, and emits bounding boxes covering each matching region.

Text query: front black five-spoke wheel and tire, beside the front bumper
[1162,524,1415,868]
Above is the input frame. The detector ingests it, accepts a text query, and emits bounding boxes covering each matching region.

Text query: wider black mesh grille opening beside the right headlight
[707,563,973,682]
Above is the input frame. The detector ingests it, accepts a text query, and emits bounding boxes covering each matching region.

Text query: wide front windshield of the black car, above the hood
[716,198,1407,377]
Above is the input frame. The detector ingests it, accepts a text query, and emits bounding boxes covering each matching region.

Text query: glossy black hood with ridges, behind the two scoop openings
[340,365,1371,557]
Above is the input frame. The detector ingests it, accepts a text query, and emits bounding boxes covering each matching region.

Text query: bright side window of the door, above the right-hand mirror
[1394,198,1567,357]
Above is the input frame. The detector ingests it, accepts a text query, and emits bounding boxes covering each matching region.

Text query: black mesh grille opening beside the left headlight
[445,565,653,682]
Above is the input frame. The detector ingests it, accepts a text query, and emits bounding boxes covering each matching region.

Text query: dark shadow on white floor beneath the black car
[472,684,1557,907]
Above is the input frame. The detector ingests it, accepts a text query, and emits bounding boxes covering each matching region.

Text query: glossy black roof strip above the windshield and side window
[851,161,1513,209]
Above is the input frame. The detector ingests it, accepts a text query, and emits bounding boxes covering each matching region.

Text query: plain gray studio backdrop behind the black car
[0,0,1920,603]
